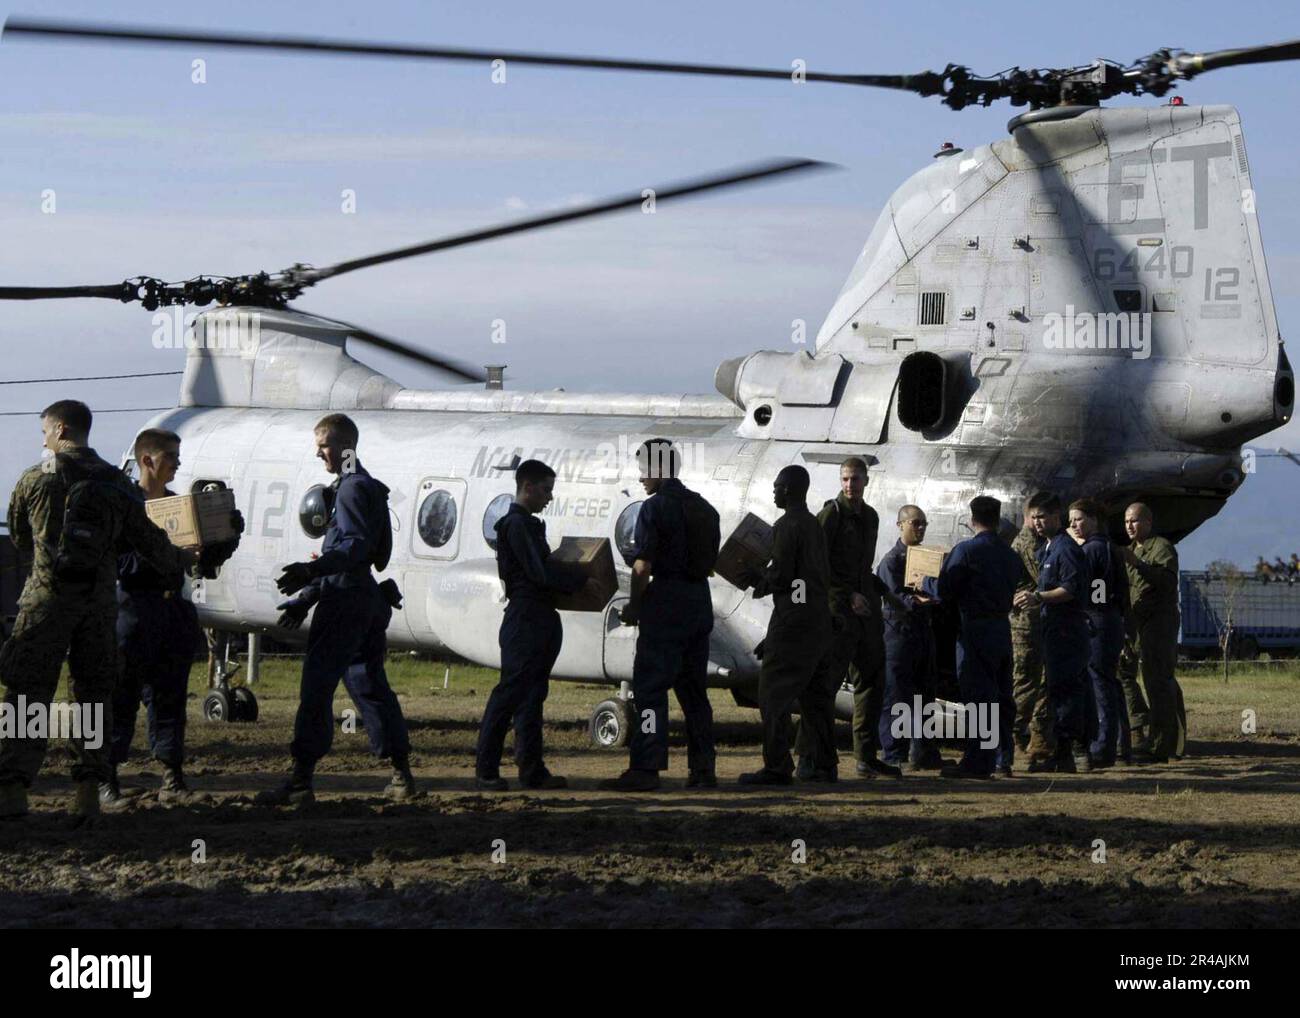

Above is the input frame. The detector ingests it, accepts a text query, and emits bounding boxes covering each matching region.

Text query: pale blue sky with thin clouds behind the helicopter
[0,0,1300,566]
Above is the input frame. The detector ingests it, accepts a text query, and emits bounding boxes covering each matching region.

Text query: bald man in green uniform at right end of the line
[1121,502,1187,763]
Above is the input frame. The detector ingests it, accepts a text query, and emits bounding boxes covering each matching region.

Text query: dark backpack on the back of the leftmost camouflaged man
[55,460,130,584]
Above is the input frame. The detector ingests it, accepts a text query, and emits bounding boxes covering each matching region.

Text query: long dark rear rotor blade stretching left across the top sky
[4,17,939,95]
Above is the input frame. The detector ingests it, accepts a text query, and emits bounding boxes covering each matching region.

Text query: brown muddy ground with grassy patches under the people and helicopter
[0,660,1300,928]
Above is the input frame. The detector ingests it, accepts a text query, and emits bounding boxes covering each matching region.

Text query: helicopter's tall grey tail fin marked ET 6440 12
[816,104,1295,449]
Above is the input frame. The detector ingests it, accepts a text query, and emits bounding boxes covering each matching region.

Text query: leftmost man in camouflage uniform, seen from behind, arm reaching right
[0,399,196,818]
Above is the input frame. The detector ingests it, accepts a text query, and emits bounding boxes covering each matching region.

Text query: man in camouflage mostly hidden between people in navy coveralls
[1011,491,1054,761]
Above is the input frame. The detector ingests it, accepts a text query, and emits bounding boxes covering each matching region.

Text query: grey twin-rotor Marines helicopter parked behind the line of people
[0,20,1300,745]
